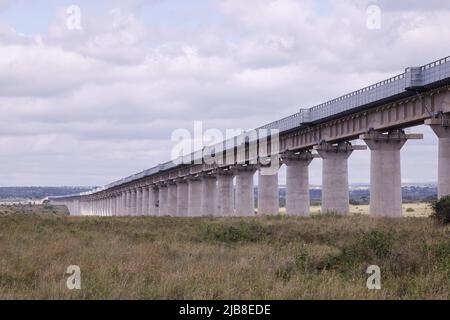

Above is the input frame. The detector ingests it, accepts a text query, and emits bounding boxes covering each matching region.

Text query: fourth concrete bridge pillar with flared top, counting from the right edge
[282,151,315,217]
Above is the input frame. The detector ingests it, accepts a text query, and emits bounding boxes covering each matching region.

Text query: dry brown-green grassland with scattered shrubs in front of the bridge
[0,206,450,299]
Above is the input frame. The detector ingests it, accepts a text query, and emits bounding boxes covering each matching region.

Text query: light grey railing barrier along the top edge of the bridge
[48,56,450,196]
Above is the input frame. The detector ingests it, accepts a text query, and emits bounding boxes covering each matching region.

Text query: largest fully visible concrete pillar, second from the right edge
[360,131,423,217]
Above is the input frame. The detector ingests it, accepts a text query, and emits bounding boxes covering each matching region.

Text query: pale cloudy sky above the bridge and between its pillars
[0,0,450,186]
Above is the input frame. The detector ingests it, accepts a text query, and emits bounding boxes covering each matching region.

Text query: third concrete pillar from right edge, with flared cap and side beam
[314,142,367,215]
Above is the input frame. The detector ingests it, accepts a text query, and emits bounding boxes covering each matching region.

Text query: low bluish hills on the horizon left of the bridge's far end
[0,187,95,200]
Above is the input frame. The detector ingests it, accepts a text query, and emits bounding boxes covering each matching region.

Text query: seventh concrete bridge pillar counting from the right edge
[217,170,234,217]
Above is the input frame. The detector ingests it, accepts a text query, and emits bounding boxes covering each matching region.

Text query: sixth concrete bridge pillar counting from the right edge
[235,165,256,217]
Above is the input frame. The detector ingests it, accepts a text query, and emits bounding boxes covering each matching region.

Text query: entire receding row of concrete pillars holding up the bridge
[68,122,450,217]
